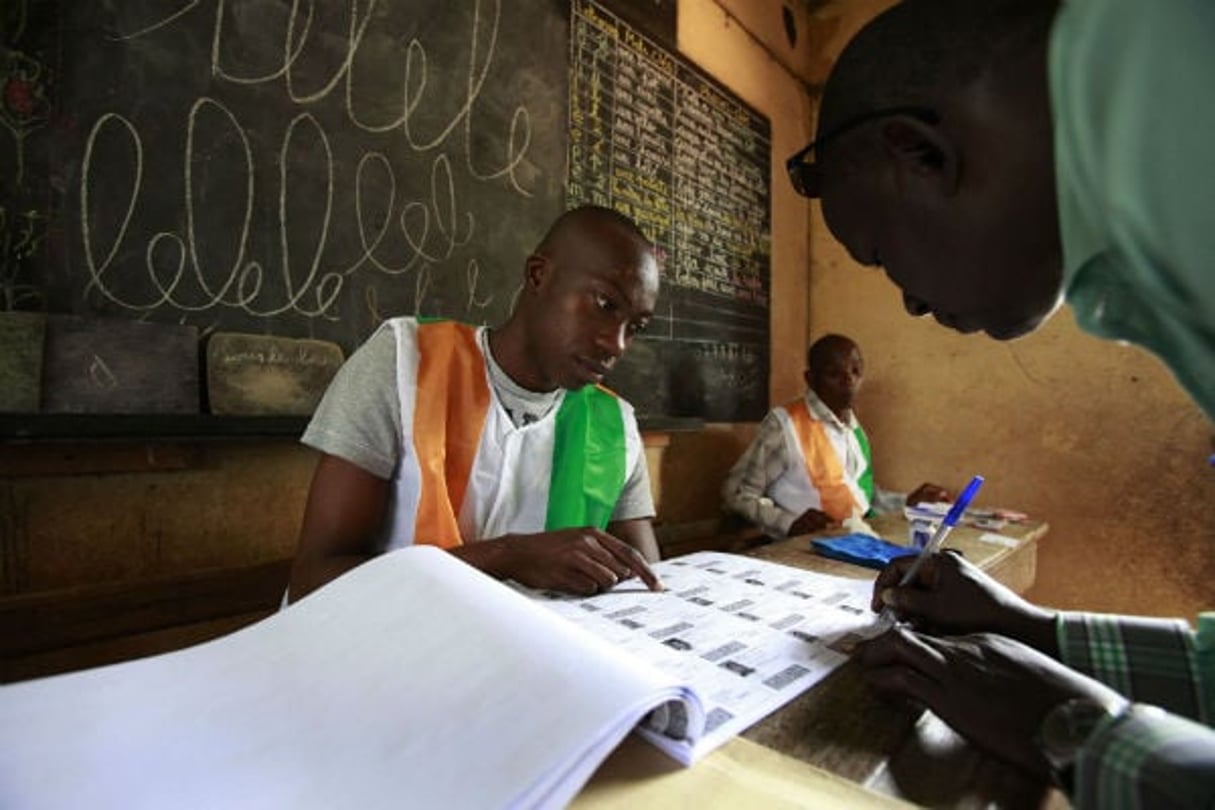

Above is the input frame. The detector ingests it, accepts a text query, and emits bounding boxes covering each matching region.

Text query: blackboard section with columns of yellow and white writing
[569,0,772,421]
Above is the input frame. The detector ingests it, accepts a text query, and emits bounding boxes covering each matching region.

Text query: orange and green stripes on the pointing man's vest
[413,321,626,548]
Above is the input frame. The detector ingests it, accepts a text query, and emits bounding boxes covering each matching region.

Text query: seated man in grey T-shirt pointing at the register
[289,206,661,601]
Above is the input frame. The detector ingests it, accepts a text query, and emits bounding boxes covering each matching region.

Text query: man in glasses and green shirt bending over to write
[789,0,1215,810]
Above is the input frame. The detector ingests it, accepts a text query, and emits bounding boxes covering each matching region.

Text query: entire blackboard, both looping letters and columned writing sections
[0,0,770,420]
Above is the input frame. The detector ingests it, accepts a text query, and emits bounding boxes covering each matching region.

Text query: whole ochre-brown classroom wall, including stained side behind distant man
[7,0,1215,680]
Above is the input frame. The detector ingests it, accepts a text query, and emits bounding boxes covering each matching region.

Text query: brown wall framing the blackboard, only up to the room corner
[0,0,812,680]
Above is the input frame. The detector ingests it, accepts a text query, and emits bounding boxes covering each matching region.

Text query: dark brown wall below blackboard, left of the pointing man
[0,438,315,684]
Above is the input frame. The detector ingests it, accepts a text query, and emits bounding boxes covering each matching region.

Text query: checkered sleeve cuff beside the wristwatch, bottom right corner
[1072,704,1215,810]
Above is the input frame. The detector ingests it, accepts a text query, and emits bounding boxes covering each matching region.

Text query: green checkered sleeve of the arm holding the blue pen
[1056,613,1215,724]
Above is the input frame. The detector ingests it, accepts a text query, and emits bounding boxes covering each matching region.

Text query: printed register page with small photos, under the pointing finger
[529,551,880,764]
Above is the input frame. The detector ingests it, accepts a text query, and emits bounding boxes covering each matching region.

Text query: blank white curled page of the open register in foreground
[0,548,699,810]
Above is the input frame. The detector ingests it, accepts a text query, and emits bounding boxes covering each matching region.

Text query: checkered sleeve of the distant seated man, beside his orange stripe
[722,412,797,538]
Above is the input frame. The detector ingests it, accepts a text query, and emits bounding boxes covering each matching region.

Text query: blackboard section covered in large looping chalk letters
[22,0,569,352]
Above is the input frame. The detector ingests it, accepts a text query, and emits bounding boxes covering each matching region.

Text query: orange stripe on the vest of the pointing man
[413,321,490,549]
